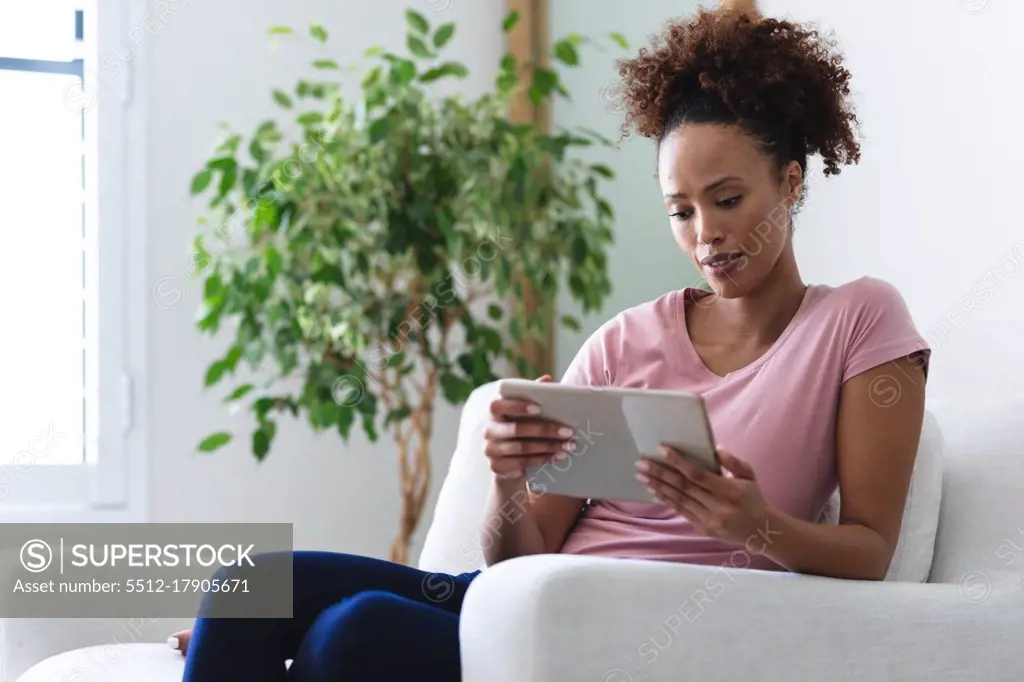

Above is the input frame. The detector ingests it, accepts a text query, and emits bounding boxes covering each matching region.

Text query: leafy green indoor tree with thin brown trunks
[191,10,625,562]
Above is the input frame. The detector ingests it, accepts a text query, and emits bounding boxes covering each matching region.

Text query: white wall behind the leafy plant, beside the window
[139,0,504,556]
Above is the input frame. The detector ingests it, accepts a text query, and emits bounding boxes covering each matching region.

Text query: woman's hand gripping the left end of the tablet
[483,375,572,480]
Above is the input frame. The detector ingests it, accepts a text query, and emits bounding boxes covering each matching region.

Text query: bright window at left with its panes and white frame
[0,0,141,520]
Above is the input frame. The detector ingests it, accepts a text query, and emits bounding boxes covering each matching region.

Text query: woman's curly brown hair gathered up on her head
[618,9,860,175]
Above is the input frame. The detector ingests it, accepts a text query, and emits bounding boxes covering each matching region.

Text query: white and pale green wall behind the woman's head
[553,0,1024,401]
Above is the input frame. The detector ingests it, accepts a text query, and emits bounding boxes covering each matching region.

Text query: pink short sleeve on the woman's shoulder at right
[843,278,931,383]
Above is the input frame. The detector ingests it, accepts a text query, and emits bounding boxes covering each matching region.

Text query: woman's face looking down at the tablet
[657,125,801,298]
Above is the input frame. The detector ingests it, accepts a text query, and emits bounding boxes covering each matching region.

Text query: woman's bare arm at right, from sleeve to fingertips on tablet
[638,350,925,580]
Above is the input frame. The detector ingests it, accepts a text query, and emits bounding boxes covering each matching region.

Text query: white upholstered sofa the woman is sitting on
[9,386,1024,682]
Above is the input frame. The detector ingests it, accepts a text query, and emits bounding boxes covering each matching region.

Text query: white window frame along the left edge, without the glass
[0,0,148,522]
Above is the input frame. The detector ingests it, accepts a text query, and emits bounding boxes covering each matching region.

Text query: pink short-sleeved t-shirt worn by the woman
[560,278,930,569]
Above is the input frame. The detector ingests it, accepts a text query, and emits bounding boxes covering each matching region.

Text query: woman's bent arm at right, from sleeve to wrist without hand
[764,350,925,580]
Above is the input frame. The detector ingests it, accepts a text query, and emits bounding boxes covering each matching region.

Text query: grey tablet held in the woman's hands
[498,379,721,503]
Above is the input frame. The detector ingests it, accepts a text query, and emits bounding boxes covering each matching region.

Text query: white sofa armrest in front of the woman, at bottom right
[460,555,1024,682]
